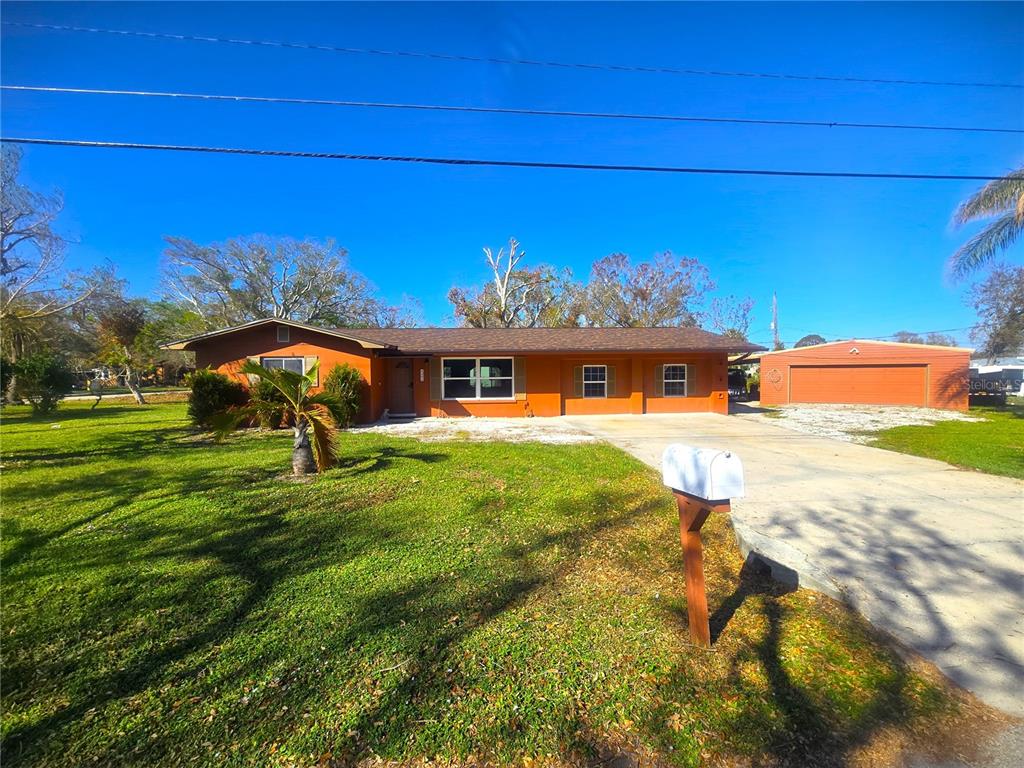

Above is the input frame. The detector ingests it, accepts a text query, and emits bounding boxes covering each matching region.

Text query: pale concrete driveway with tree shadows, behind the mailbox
[566,414,1024,716]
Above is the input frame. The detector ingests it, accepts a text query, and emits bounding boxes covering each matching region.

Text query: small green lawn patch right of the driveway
[871,400,1024,478]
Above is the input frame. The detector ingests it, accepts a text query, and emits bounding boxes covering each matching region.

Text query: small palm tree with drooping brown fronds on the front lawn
[213,360,344,475]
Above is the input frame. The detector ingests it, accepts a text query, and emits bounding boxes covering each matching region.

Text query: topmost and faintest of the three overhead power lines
[3,22,1024,88]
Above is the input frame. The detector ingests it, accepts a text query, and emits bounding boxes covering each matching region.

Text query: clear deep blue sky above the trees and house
[2,3,1024,343]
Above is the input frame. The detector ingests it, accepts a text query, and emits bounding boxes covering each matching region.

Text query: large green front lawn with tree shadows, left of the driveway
[0,403,988,767]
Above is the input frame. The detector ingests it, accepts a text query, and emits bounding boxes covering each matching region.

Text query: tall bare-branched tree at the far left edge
[0,144,114,397]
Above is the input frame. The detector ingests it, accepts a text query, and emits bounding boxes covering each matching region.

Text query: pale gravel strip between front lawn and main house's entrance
[353,417,597,444]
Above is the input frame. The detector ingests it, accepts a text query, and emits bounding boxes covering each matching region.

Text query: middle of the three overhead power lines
[6,85,1024,133]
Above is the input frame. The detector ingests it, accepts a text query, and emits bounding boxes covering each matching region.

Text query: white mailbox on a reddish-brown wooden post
[662,443,744,647]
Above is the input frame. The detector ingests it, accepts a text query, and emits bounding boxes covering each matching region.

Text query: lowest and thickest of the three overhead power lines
[0,136,1001,181]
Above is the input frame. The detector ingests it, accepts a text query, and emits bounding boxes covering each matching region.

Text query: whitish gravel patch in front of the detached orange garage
[745,403,982,443]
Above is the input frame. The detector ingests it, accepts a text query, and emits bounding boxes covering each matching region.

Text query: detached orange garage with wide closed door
[761,339,971,411]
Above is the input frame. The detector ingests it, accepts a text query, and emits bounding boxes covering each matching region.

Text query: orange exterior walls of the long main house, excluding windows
[195,324,729,423]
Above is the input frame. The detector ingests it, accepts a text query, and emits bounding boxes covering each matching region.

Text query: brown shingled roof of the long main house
[165,318,765,354]
